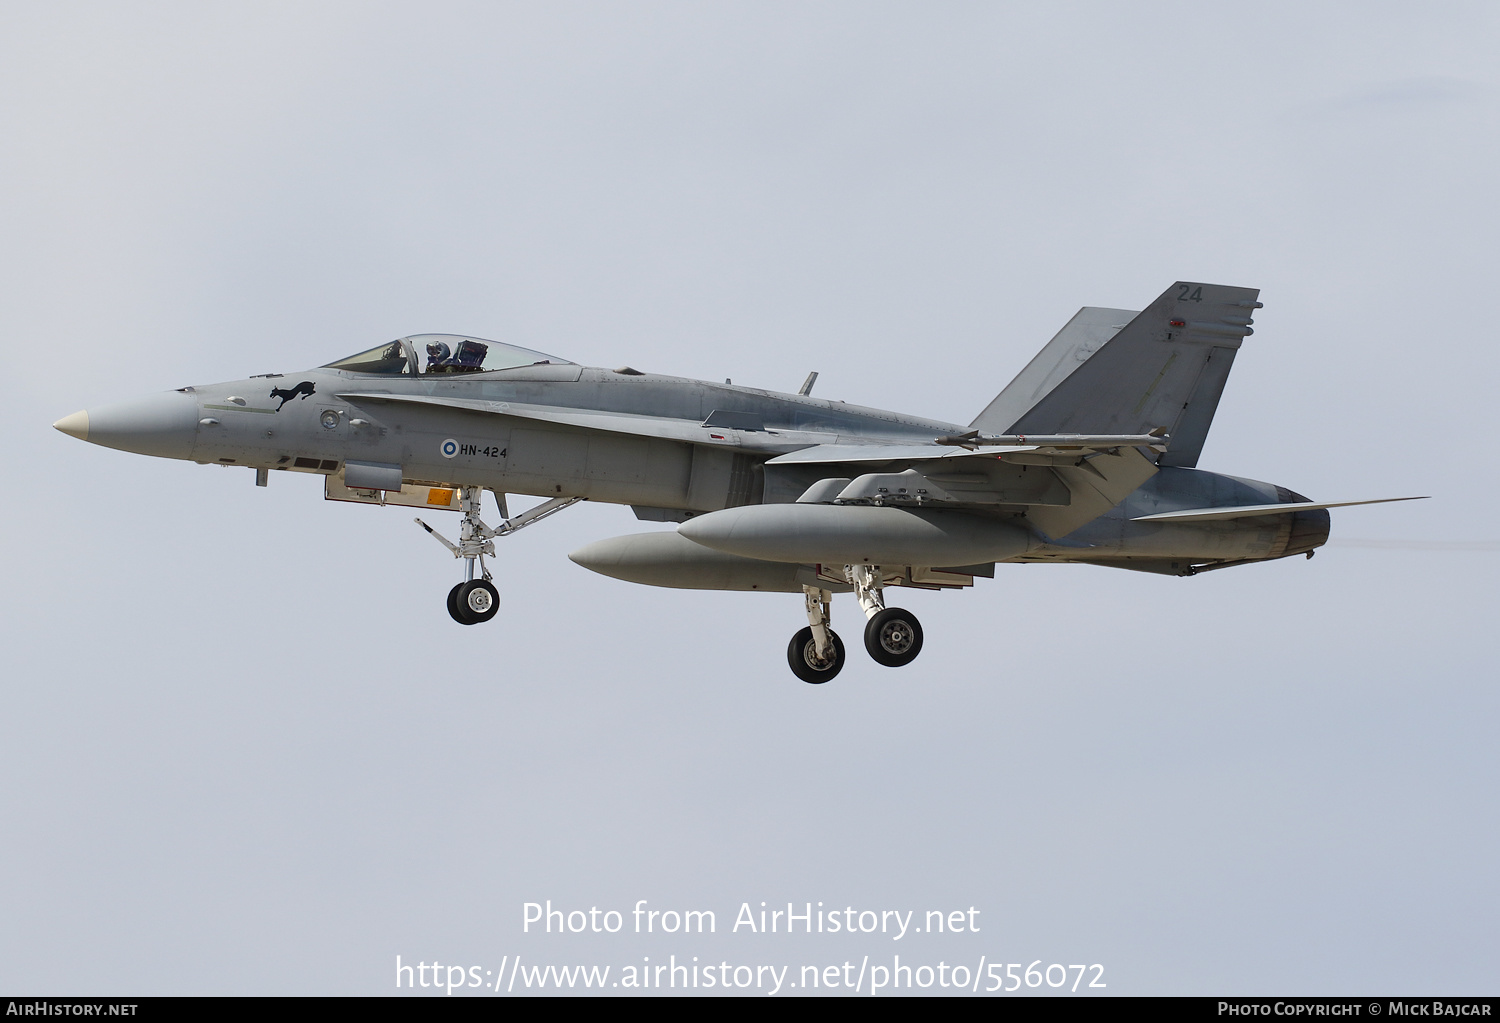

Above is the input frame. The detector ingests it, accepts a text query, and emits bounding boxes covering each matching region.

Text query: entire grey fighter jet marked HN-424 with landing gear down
[56,282,1415,683]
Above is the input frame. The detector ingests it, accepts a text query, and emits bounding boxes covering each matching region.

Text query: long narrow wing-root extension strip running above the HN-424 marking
[339,392,834,453]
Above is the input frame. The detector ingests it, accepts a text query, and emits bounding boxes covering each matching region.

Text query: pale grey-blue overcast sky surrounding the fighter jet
[0,0,1500,995]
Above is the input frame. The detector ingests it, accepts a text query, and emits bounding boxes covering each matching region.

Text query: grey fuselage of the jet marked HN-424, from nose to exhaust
[61,365,1328,575]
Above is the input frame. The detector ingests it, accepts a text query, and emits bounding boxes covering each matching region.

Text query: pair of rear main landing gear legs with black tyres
[786,566,923,686]
